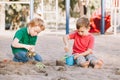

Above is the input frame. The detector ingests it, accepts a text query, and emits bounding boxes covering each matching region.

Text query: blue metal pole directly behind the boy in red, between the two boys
[65,0,70,34]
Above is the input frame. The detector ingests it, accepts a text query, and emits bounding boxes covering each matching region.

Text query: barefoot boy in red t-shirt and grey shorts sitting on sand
[63,17,103,68]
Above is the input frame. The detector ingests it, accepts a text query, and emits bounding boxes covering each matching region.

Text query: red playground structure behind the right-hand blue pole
[90,9,110,33]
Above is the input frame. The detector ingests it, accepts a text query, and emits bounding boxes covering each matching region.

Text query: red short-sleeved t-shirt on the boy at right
[69,32,94,54]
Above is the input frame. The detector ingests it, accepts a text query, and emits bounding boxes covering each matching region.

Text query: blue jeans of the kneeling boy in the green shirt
[13,51,42,62]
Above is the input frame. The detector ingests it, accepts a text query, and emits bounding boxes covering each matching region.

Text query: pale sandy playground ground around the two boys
[0,31,120,80]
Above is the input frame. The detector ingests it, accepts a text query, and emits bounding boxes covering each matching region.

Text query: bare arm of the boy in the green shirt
[12,38,34,50]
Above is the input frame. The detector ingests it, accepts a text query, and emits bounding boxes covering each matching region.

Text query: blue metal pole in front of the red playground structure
[101,0,105,34]
